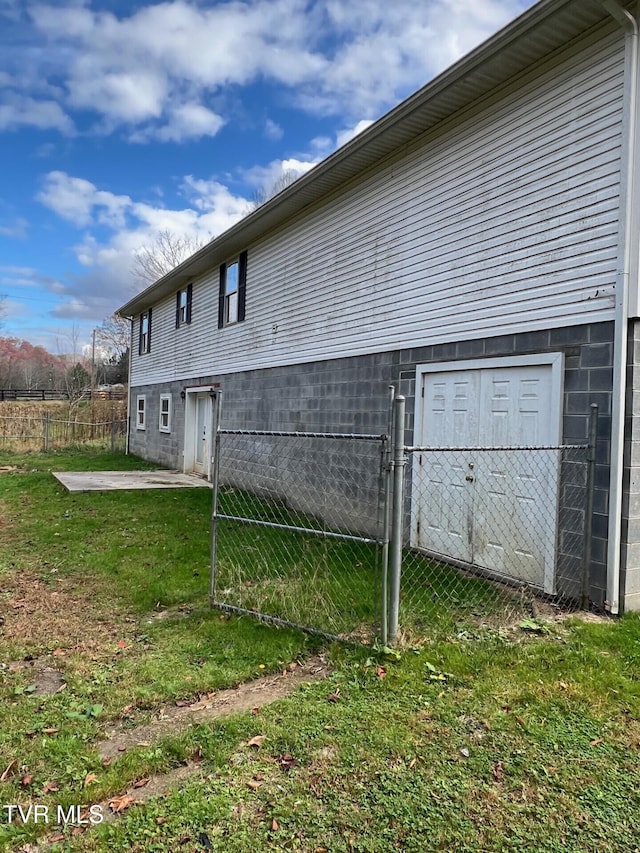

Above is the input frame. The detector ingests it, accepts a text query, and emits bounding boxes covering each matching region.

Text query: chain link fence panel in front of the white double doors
[399,445,593,628]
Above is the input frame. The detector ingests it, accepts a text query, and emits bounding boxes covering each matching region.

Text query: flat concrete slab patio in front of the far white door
[51,471,210,492]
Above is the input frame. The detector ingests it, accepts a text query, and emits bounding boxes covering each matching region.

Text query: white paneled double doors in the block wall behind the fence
[413,356,561,592]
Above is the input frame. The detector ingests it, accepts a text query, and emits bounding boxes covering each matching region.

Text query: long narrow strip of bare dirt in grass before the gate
[98,656,329,760]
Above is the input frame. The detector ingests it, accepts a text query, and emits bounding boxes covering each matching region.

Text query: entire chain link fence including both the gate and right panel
[210,392,597,644]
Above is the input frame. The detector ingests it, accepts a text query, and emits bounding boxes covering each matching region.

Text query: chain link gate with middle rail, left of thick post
[210,391,388,642]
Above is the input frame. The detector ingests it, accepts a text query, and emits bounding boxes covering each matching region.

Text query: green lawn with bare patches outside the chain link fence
[0,452,640,853]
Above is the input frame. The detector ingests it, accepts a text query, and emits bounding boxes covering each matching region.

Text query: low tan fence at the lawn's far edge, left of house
[0,412,127,452]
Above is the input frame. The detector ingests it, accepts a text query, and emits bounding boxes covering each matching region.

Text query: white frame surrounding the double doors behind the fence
[410,352,564,593]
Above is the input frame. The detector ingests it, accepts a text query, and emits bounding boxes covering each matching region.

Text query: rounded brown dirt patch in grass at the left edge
[0,571,127,660]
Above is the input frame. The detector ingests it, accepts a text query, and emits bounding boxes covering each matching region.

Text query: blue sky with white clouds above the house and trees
[0,0,533,354]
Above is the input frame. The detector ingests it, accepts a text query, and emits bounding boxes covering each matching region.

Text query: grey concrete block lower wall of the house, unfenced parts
[130,322,616,606]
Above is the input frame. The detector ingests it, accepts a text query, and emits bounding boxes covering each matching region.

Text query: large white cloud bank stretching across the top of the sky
[13,0,531,142]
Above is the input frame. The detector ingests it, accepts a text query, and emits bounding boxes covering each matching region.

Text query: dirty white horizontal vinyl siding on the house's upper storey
[132,27,624,384]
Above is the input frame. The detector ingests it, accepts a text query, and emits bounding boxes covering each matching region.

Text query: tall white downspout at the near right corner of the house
[600,0,638,614]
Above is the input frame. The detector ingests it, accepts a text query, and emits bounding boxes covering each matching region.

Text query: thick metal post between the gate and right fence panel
[389,394,407,645]
